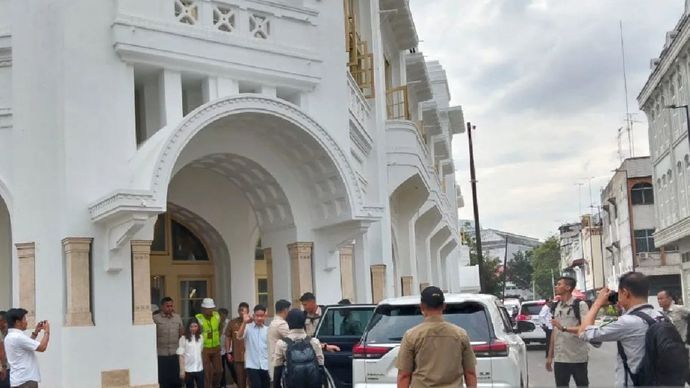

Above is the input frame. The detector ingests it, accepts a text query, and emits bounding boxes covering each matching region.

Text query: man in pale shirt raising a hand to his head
[237,304,271,388]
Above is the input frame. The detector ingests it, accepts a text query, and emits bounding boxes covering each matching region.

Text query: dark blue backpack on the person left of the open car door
[282,337,323,388]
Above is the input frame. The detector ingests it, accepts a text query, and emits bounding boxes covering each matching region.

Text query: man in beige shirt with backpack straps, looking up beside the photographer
[546,276,589,387]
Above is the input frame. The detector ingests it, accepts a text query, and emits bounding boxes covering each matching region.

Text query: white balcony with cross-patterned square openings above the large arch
[112,0,322,91]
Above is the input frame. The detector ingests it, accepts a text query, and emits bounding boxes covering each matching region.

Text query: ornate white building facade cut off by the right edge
[637,2,690,300]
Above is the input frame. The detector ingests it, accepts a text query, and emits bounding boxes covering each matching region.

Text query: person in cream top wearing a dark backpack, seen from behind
[272,309,324,388]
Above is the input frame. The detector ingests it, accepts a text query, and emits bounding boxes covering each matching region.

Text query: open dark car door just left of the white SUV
[316,305,375,388]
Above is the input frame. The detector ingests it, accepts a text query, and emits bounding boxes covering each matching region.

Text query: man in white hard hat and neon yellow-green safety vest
[196,298,223,387]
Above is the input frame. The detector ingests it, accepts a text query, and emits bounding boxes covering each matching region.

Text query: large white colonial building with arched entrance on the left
[0,0,467,388]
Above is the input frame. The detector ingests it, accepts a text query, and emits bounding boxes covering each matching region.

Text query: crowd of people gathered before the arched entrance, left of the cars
[154,292,338,388]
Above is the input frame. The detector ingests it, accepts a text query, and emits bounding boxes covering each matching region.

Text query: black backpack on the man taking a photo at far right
[618,305,688,387]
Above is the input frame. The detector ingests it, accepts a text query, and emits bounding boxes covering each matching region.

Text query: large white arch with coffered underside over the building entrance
[132,94,368,227]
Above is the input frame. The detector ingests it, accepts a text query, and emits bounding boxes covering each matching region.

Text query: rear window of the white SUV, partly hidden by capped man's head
[365,302,491,344]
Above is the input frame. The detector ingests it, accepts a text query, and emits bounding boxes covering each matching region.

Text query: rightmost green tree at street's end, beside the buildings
[532,236,561,298]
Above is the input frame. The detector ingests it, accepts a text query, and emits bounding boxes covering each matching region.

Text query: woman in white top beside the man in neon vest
[177,318,204,388]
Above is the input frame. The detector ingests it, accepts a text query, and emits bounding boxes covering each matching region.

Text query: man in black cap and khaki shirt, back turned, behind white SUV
[396,286,477,388]
